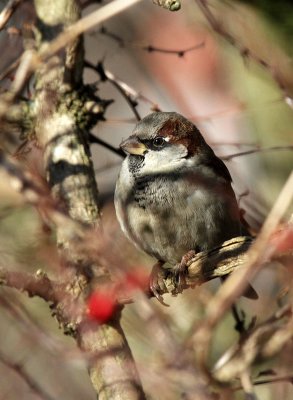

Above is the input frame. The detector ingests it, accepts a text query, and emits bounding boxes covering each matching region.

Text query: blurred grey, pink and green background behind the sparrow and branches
[0,0,293,400]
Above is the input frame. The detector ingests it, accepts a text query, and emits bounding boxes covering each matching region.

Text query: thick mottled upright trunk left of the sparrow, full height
[31,0,145,400]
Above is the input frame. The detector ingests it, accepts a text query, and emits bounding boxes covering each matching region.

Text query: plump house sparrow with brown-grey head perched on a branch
[115,112,253,300]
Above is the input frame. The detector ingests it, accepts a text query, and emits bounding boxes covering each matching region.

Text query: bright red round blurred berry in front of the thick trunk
[87,291,116,323]
